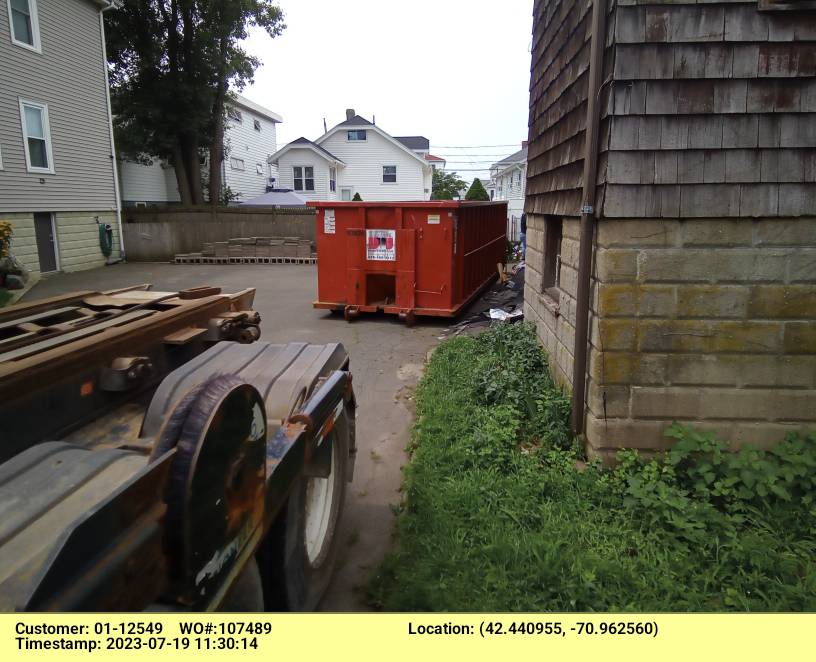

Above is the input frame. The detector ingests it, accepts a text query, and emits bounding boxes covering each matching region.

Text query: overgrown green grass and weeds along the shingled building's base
[368,324,816,611]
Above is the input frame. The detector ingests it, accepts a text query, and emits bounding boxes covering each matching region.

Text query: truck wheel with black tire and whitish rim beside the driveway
[258,407,354,611]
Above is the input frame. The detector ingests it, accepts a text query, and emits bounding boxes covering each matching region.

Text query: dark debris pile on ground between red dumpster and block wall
[439,262,524,340]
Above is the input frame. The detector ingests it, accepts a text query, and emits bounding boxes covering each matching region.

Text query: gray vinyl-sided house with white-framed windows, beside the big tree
[0,0,121,273]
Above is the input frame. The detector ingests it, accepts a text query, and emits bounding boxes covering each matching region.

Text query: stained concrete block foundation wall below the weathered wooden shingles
[525,215,816,460]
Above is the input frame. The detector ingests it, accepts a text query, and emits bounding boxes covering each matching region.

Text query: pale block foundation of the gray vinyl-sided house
[0,210,120,274]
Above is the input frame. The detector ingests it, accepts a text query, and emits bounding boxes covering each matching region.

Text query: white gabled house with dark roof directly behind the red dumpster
[269,109,433,201]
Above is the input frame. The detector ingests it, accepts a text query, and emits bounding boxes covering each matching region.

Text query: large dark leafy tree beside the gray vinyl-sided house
[107,0,286,204]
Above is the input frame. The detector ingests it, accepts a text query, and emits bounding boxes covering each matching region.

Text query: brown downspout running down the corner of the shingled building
[570,0,607,435]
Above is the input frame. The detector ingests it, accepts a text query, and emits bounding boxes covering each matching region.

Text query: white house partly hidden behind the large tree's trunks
[120,94,283,206]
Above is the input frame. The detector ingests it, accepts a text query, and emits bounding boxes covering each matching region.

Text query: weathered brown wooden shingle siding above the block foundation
[527,0,816,218]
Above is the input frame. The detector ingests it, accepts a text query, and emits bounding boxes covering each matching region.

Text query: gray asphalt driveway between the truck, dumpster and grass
[24,263,447,611]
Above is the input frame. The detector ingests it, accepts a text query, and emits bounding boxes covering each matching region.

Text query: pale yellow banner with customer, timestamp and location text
[0,613,816,662]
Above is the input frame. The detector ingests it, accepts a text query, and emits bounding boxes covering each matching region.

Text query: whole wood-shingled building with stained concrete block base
[525,0,816,459]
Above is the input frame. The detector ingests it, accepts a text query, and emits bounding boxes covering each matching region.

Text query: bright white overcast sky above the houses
[243,0,533,181]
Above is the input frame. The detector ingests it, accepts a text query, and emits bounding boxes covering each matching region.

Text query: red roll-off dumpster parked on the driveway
[308,200,507,321]
